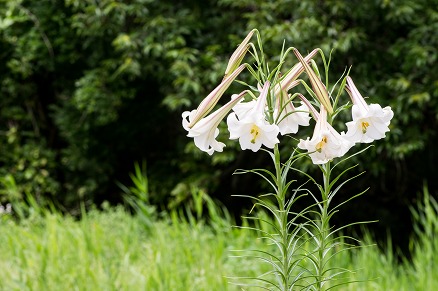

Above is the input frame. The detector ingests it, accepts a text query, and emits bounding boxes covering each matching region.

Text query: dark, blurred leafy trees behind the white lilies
[0,0,438,251]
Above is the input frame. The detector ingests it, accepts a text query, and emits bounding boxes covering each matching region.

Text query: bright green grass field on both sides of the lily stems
[0,193,438,291]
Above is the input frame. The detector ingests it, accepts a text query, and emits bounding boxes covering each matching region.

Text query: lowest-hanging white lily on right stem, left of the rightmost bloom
[298,106,354,164]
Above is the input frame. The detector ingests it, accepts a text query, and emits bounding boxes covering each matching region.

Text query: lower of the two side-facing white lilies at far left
[182,91,246,155]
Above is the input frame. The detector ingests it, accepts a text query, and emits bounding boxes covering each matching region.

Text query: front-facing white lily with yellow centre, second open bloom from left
[227,81,280,152]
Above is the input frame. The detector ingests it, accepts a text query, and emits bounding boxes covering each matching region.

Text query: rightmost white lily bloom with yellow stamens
[346,77,394,143]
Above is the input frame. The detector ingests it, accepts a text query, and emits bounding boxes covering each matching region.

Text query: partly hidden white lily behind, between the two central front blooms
[278,102,311,135]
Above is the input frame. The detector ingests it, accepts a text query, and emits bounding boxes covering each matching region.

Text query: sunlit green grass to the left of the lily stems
[0,208,270,290]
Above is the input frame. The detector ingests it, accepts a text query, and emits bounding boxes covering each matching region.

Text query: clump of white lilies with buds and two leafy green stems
[182,29,393,291]
